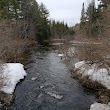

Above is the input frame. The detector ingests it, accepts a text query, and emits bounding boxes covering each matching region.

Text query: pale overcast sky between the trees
[36,0,99,26]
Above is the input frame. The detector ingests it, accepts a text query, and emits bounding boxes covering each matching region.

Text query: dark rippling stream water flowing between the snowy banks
[4,48,96,110]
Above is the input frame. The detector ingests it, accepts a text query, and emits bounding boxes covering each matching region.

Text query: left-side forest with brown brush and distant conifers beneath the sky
[0,0,74,62]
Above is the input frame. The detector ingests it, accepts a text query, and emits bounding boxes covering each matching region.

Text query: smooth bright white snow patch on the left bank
[1,63,27,94]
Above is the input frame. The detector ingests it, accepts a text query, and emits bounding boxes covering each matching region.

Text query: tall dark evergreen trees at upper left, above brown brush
[0,0,50,43]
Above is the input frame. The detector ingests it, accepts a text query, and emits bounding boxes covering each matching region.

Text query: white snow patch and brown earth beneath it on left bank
[0,63,27,108]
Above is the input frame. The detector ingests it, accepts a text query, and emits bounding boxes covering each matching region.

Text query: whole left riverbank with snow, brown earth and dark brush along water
[0,42,36,109]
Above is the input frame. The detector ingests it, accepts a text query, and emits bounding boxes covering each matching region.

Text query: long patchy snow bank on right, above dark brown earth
[75,61,110,90]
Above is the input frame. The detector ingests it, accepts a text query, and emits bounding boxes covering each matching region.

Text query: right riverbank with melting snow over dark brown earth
[72,61,110,110]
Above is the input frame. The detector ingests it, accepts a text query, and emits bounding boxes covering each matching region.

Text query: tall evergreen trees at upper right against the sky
[80,0,110,38]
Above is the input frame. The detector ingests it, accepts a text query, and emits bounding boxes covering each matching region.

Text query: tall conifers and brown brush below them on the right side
[78,0,110,65]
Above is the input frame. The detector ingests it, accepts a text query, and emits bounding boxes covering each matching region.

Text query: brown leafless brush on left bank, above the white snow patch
[0,20,37,93]
